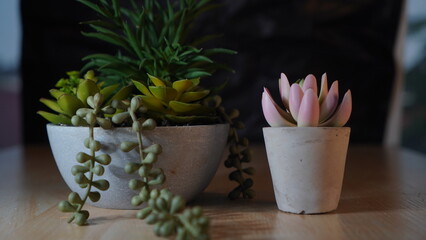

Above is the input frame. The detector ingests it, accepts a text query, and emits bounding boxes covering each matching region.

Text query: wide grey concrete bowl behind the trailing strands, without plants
[47,124,229,209]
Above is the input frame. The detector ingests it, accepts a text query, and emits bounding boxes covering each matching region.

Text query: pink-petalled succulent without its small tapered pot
[262,73,352,127]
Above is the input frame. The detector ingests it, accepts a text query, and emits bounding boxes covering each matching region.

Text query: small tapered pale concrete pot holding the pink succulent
[263,127,350,214]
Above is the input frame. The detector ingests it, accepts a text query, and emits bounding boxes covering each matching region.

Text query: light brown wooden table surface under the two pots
[0,143,426,240]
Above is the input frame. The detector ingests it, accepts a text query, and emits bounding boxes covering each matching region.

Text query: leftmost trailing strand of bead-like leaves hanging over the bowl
[58,93,115,225]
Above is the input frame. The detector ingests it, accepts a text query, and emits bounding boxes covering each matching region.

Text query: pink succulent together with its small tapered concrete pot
[262,74,352,214]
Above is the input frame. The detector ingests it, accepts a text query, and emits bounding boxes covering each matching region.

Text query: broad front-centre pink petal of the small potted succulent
[297,88,319,127]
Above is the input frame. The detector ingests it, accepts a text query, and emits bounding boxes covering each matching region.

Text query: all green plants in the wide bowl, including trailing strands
[37,0,254,239]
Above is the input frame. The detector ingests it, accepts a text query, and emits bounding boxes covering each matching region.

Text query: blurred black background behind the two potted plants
[1,0,426,150]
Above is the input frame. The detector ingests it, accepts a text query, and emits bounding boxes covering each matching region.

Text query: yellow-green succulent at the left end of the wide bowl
[37,70,133,125]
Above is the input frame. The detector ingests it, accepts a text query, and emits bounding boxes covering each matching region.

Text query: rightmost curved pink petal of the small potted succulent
[320,90,352,127]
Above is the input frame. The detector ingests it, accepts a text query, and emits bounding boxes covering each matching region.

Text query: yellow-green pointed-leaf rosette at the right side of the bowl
[133,75,219,124]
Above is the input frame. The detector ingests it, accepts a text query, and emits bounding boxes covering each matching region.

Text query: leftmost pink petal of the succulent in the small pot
[262,88,296,127]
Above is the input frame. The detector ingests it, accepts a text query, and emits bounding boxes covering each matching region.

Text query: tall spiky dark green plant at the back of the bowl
[79,0,236,85]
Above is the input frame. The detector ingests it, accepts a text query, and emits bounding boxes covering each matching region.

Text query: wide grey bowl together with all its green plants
[38,0,254,239]
